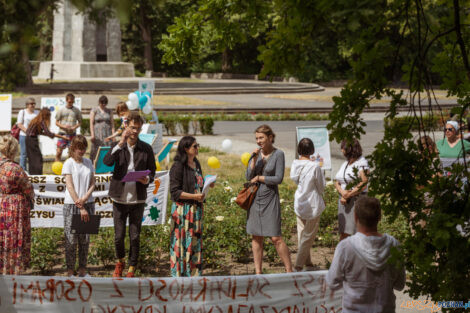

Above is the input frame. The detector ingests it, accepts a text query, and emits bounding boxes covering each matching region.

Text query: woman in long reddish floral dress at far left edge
[0,135,34,275]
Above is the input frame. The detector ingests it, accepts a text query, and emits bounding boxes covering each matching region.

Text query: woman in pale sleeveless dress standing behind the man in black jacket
[90,96,114,163]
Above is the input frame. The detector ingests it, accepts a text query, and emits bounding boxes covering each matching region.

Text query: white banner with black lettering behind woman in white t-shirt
[29,171,169,227]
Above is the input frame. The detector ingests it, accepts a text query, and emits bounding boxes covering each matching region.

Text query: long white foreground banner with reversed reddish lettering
[0,271,342,313]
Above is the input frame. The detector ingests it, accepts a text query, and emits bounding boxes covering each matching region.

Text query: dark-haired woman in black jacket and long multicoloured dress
[170,136,210,277]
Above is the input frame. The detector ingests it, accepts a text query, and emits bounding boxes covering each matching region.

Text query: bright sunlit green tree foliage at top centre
[159,0,270,72]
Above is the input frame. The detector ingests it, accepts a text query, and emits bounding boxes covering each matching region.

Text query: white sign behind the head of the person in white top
[296,126,331,170]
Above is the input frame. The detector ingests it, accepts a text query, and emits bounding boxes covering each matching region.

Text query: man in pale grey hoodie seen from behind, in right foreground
[326,196,406,313]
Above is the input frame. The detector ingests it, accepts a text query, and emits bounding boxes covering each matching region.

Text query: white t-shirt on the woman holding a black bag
[62,158,95,204]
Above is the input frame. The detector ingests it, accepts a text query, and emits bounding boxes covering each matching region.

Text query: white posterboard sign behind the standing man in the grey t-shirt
[39,97,82,157]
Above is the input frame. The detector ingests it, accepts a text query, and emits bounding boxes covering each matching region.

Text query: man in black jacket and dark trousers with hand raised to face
[103,112,156,277]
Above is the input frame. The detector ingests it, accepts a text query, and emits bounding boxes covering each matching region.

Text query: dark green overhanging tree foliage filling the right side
[328,0,470,301]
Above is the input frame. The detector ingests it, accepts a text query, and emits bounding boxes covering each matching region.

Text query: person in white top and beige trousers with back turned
[290,138,325,271]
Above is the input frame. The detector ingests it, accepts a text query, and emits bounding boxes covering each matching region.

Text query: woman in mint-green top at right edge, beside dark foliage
[436,121,470,175]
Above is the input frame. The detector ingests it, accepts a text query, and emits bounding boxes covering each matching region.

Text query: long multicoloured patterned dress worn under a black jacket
[170,170,204,277]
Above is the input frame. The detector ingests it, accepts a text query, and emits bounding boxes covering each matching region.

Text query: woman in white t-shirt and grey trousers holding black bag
[62,135,95,277]
